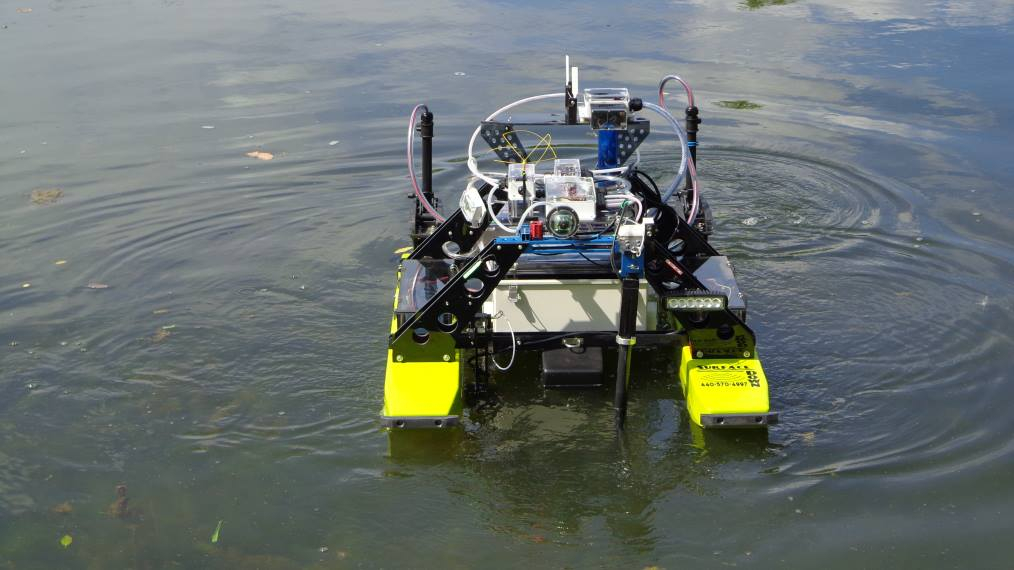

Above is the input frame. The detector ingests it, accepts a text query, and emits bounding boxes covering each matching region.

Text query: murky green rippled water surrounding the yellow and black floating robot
[0,0,1014,569]
